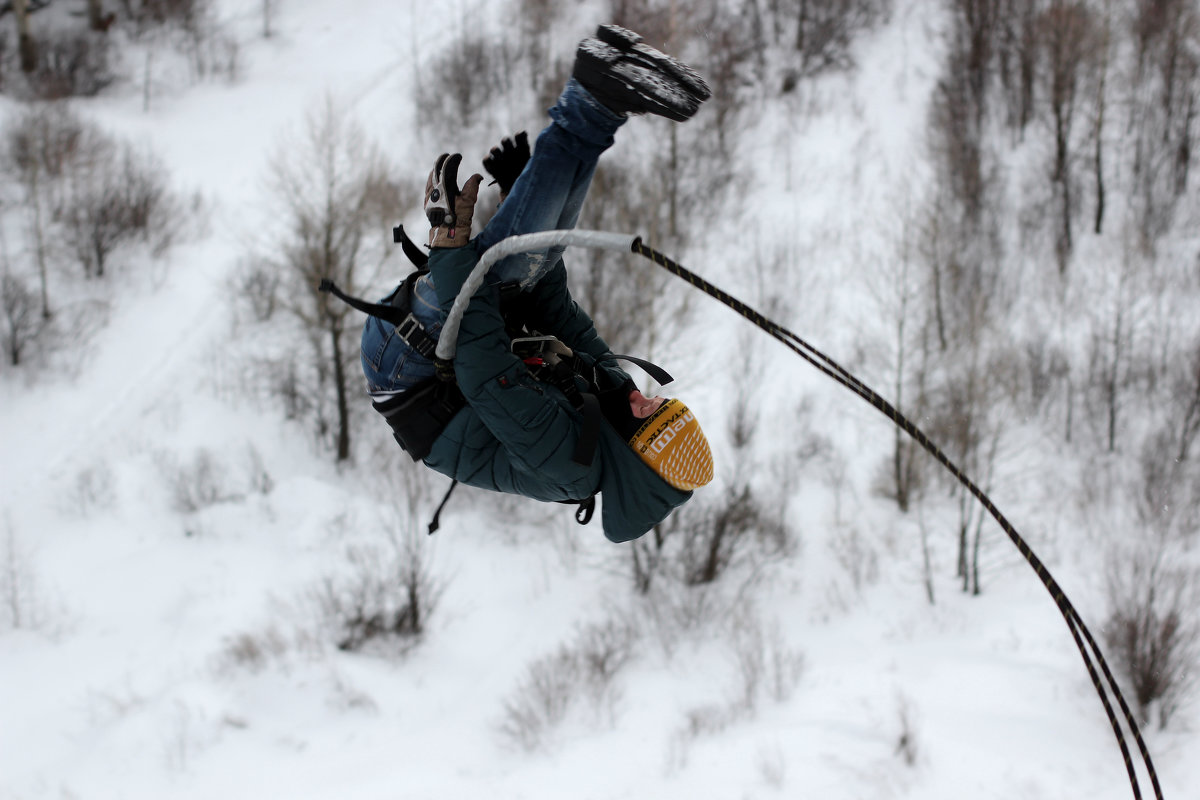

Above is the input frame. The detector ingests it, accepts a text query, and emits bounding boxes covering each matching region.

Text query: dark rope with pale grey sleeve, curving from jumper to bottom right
[437,230,1163,800]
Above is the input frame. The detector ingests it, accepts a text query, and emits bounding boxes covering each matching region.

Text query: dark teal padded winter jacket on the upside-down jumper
[425,243,691,542]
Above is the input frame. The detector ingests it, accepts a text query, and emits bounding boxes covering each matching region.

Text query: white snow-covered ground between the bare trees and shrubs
[0,0,1200,800]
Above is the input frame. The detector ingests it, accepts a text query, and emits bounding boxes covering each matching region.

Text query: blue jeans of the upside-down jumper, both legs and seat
[361,78,625,392]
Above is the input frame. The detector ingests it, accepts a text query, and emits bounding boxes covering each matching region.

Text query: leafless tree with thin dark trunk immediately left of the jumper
[266,98,401,461]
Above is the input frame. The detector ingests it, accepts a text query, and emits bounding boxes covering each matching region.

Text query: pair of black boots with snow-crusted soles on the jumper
[574,25,709,122]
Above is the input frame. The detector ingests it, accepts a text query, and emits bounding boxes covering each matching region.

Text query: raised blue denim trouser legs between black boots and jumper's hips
[476,78,626,288]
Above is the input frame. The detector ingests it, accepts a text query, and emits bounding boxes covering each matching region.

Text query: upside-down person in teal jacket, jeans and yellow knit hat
[352,25,713,542]
